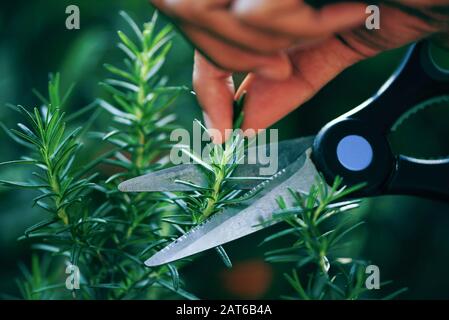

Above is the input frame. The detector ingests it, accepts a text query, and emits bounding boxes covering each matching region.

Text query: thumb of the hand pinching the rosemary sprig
[236,38,361,130]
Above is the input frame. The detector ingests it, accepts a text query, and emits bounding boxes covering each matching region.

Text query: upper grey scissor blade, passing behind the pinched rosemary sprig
[119,137,314,192]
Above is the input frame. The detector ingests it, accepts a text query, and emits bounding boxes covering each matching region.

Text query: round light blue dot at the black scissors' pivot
[337,135,373,171]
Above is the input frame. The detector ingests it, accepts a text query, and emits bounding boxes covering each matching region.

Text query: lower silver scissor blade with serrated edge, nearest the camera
[145,149,319,267]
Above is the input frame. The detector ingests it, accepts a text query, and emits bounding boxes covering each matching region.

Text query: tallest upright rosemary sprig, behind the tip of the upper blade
[90,12,193,298]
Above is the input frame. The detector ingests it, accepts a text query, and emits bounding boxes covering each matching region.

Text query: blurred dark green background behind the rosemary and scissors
[0,0,449,299]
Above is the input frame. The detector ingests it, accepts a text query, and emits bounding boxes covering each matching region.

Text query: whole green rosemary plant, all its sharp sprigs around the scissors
[0,12,400,299]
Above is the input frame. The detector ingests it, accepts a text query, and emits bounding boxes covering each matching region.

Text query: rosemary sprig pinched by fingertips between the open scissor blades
[170,96,260,268]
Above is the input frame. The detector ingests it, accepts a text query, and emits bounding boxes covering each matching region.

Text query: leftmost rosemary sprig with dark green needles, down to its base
[0,75,98,296]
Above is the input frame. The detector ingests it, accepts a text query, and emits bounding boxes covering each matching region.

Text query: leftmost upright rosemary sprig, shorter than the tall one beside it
[0,74,96,248]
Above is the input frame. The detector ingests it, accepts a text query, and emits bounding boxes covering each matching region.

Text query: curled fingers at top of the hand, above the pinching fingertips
[151,0,365,79]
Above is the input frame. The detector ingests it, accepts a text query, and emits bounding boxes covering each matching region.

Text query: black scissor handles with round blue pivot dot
[313,41,449,201]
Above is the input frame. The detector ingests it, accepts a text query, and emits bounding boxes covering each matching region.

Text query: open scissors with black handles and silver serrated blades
[119,41,449,267]
